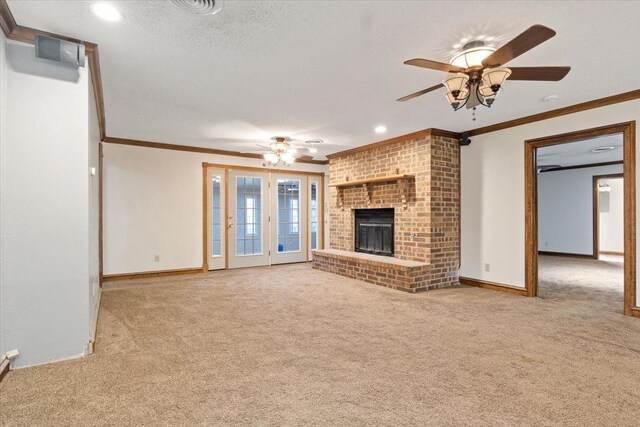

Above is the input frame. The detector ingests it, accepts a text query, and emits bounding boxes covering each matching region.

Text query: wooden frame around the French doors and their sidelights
[202,162,325,273]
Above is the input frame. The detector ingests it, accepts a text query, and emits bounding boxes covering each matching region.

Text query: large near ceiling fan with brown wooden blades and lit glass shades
[398,25,571,120]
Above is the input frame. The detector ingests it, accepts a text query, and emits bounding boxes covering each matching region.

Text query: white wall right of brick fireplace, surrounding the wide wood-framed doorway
[461,100,640,308]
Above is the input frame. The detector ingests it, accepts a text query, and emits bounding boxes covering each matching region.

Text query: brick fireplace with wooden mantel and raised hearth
[313,129,460,292]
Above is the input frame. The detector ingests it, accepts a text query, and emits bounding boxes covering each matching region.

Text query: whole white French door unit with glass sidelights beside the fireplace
[203,163,323,270]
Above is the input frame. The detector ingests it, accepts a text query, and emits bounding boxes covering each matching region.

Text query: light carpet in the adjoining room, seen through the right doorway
[538,255,624,313]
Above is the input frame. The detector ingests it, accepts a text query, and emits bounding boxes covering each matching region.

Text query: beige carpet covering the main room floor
[0,264,640,426]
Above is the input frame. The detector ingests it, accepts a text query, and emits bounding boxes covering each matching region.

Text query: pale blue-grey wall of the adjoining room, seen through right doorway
[538,165,623,255]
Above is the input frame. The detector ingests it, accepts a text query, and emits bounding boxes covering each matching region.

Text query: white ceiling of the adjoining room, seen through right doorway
[536,134,624,166]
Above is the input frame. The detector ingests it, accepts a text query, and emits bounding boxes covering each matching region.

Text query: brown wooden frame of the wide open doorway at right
[524,121,640,317]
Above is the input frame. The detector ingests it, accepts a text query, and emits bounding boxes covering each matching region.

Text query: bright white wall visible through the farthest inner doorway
[599,178,624,253]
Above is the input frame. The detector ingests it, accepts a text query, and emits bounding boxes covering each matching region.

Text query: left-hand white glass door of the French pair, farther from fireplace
[227,170,269,268]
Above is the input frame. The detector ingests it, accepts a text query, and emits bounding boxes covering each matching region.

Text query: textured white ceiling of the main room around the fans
[9,0,640,159]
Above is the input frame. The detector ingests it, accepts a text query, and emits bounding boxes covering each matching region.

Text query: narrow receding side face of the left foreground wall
[87,65,100,341]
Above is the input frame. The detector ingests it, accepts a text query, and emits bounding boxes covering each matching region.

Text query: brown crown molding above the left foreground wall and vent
[0,0,107,140]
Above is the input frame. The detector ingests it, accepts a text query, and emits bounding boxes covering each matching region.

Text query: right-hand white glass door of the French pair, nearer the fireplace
[271,174,307,264]
